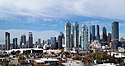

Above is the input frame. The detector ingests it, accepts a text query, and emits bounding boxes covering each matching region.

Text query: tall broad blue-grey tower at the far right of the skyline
[112,22,119,49]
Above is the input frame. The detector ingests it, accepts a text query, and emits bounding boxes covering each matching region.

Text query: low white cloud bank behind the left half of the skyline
[0,29,60,44]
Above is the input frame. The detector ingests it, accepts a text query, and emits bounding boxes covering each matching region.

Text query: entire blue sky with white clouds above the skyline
[0,0,125,44]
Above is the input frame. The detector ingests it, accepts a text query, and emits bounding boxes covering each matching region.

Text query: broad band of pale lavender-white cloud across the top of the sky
[0,0,125,19]
